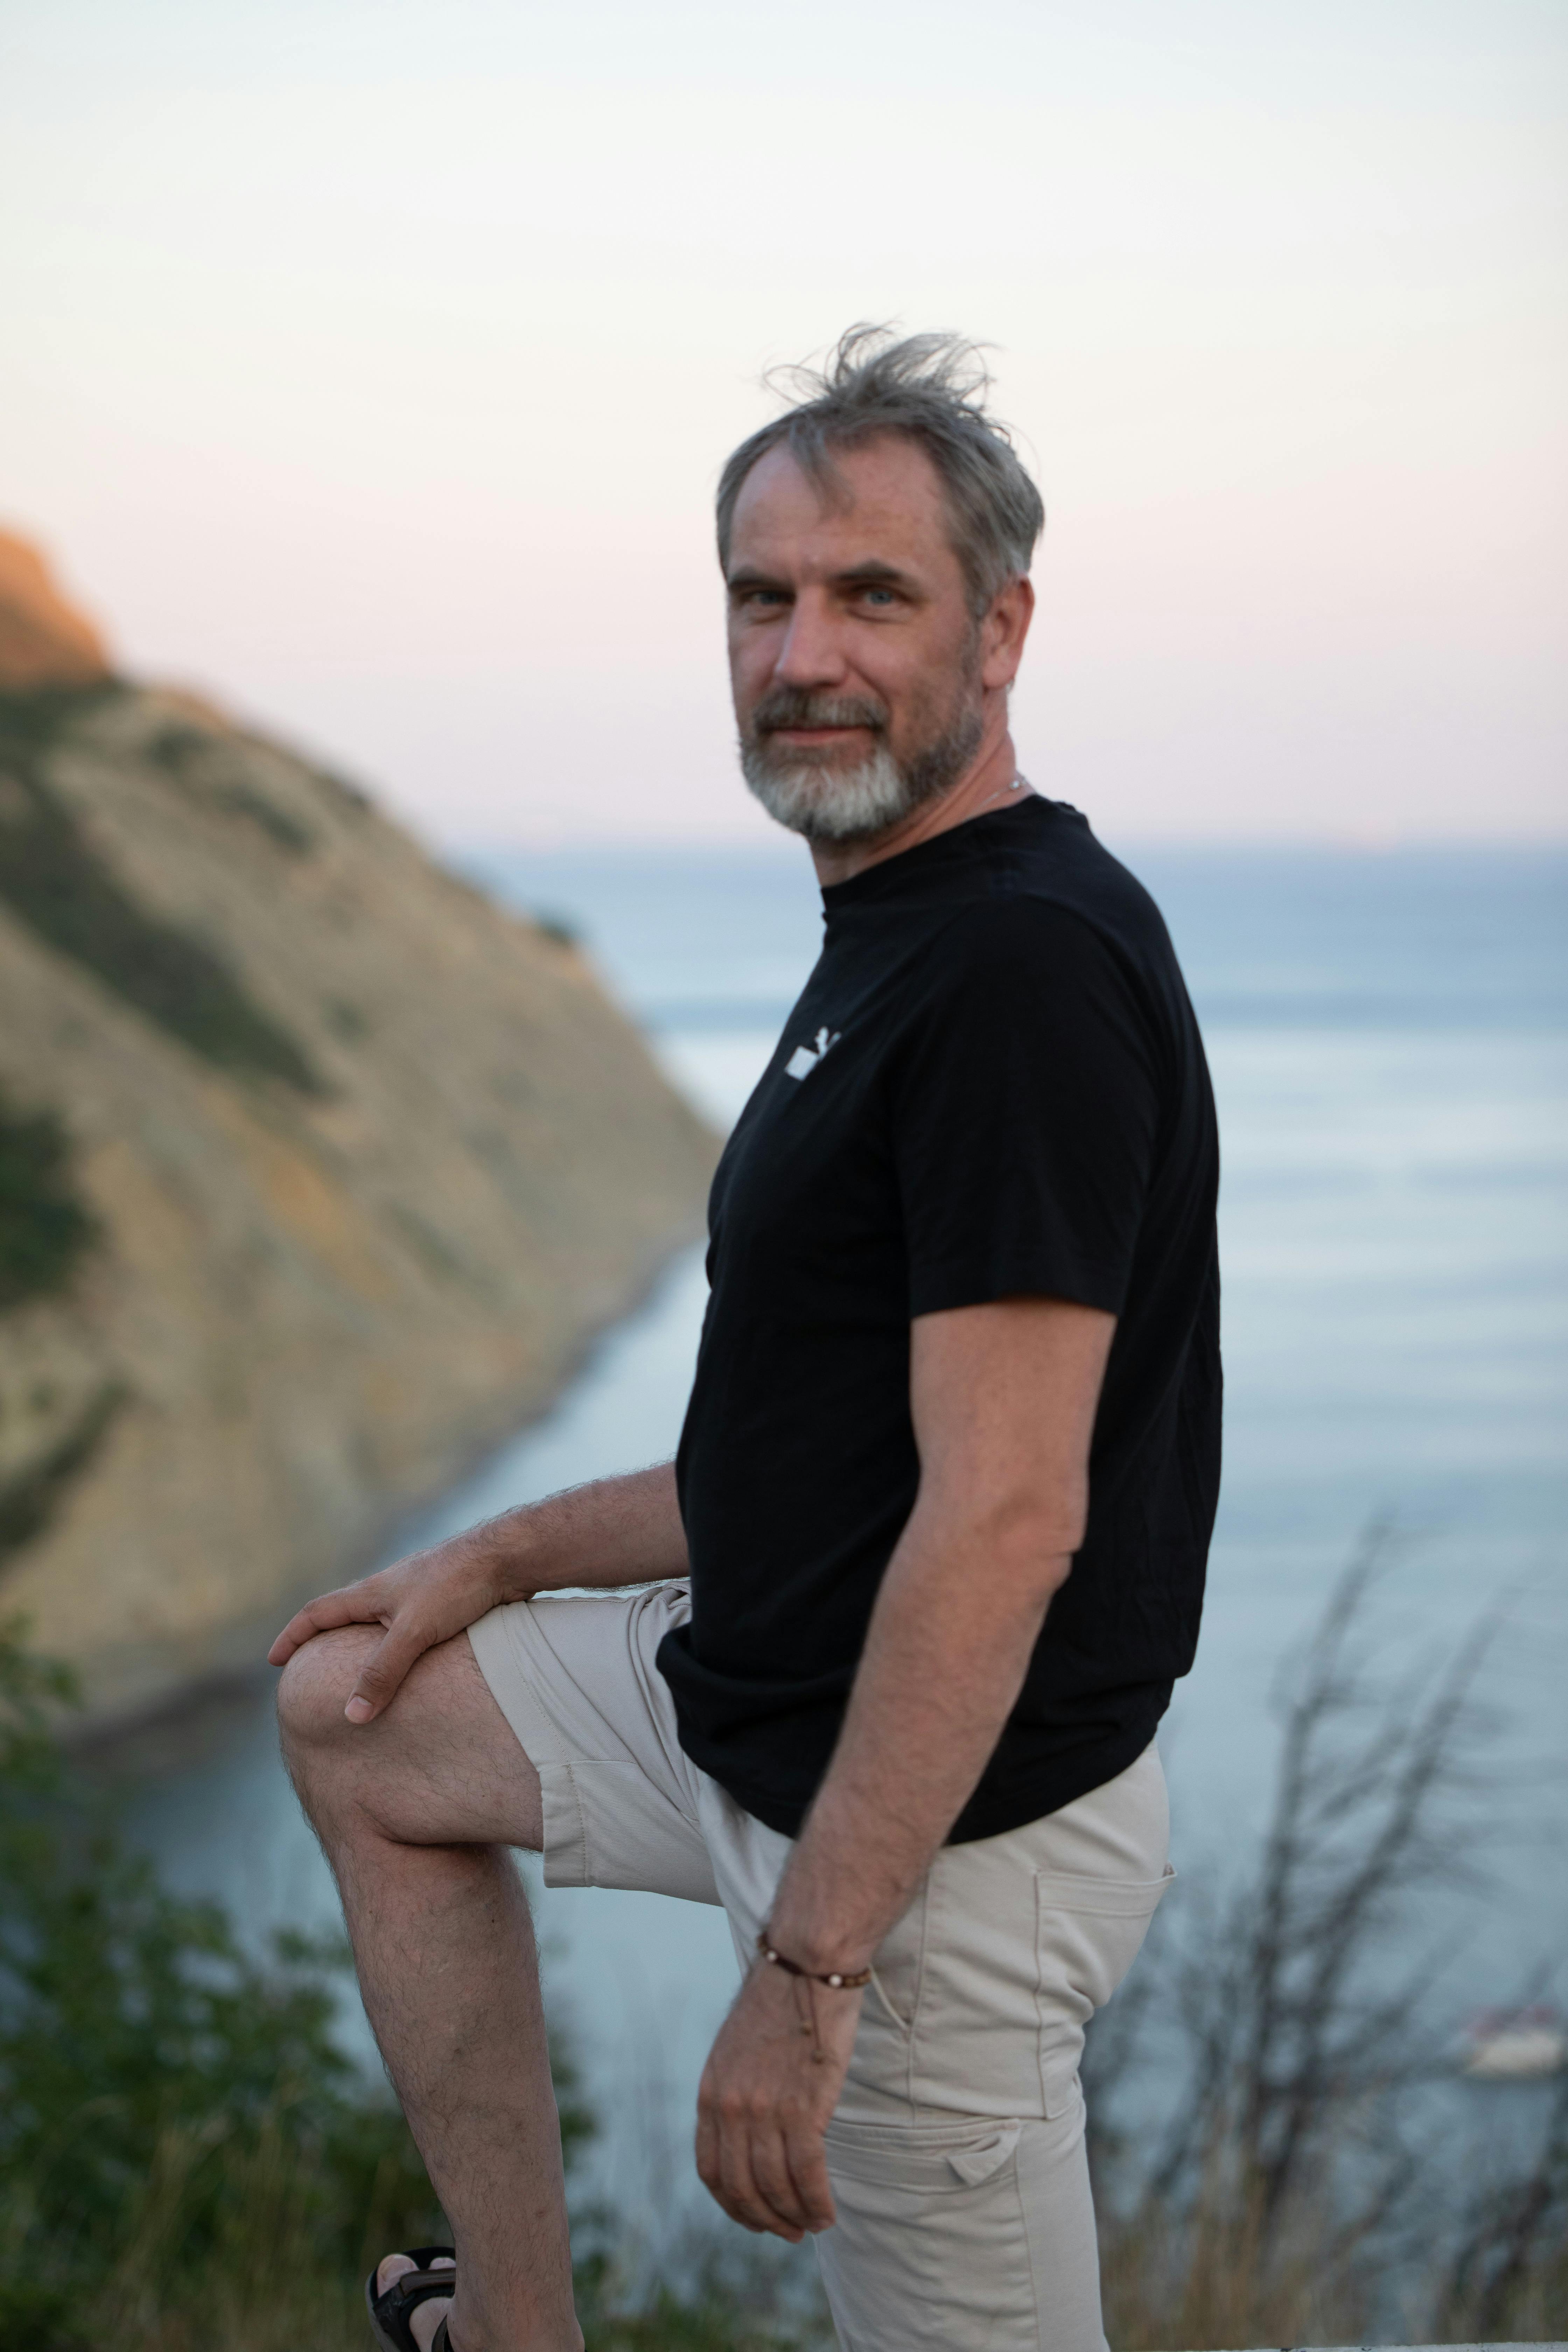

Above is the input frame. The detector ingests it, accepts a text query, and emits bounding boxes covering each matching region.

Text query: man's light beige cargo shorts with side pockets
[468,1585,1173,2352]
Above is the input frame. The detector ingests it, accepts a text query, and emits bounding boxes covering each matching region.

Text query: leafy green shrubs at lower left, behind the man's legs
[0,1625,823,2352]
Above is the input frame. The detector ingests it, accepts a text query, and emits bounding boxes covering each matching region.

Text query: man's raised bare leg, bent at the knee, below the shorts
[278,1628,583,2352]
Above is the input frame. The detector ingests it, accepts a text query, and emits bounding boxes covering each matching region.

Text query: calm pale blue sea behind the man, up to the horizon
[96,842,1568,2234]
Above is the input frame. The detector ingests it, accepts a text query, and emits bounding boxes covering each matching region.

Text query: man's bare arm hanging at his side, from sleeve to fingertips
[698,1298,1114,2237]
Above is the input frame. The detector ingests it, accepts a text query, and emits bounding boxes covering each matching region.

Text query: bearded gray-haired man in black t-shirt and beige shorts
[273,329,1220,2352]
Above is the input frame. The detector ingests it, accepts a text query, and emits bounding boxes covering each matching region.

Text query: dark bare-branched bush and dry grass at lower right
[1086,1531,1568,2352]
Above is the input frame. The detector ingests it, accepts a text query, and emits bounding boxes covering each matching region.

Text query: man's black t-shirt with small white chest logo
[658,800,1220,1842]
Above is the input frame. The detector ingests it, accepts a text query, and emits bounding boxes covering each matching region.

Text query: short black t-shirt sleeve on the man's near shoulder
[891,896,1159,1317]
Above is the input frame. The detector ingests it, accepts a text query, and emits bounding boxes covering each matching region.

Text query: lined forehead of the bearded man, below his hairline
[729,433,961,586]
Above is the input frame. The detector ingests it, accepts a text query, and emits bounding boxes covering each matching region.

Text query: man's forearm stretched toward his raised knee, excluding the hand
[479,1463,689,1600]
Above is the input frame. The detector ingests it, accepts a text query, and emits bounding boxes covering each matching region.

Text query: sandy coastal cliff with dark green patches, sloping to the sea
[0,539,715,1719]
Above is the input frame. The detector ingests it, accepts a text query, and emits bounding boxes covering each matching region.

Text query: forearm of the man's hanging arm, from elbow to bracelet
[771,1510,1072,1971]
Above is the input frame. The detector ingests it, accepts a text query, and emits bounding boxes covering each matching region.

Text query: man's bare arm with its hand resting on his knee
[268,1463,686,1724]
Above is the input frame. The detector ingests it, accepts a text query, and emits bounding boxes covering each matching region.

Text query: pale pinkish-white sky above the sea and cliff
[0,0,1568,847]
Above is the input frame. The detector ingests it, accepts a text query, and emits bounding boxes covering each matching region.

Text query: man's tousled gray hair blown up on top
[717,324,1046,621]
